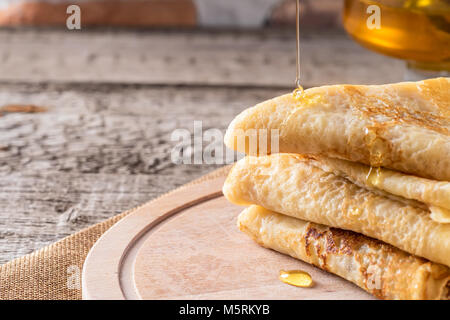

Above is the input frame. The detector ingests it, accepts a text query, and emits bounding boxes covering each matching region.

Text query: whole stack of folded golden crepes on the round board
[223,78,450,299]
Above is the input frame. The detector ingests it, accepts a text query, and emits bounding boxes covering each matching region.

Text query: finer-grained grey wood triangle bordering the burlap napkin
[0,170,189,263]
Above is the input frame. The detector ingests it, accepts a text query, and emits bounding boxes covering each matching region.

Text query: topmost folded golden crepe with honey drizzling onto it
[225,78,450,181]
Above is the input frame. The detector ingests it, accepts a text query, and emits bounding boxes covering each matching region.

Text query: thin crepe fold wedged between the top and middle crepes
[310,156,450,223]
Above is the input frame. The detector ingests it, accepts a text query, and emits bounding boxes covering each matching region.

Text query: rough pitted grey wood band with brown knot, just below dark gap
[0,86,285,174]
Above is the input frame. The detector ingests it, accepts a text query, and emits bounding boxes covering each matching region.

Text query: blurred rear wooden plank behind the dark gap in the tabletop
[0,29,404,87]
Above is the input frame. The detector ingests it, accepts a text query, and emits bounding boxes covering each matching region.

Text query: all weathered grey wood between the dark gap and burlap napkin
[0,84,285,263]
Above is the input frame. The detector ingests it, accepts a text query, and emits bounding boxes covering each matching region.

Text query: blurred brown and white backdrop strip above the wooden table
[0,0,343,28]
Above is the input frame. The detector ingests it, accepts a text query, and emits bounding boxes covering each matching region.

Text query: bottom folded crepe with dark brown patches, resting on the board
[238,206,450,300]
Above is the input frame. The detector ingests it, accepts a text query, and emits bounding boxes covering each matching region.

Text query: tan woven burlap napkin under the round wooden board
[0,166,230,300]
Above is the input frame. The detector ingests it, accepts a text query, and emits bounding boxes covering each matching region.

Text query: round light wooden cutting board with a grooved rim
[82,171,372,299]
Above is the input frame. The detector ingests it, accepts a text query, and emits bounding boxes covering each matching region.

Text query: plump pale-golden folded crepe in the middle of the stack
[223,154,450,266]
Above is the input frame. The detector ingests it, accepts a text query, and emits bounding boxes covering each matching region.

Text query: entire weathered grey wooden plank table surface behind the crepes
[0,29,403,263]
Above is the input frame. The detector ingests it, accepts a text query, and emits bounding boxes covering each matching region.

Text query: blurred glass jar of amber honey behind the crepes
[343,0,450,80]
